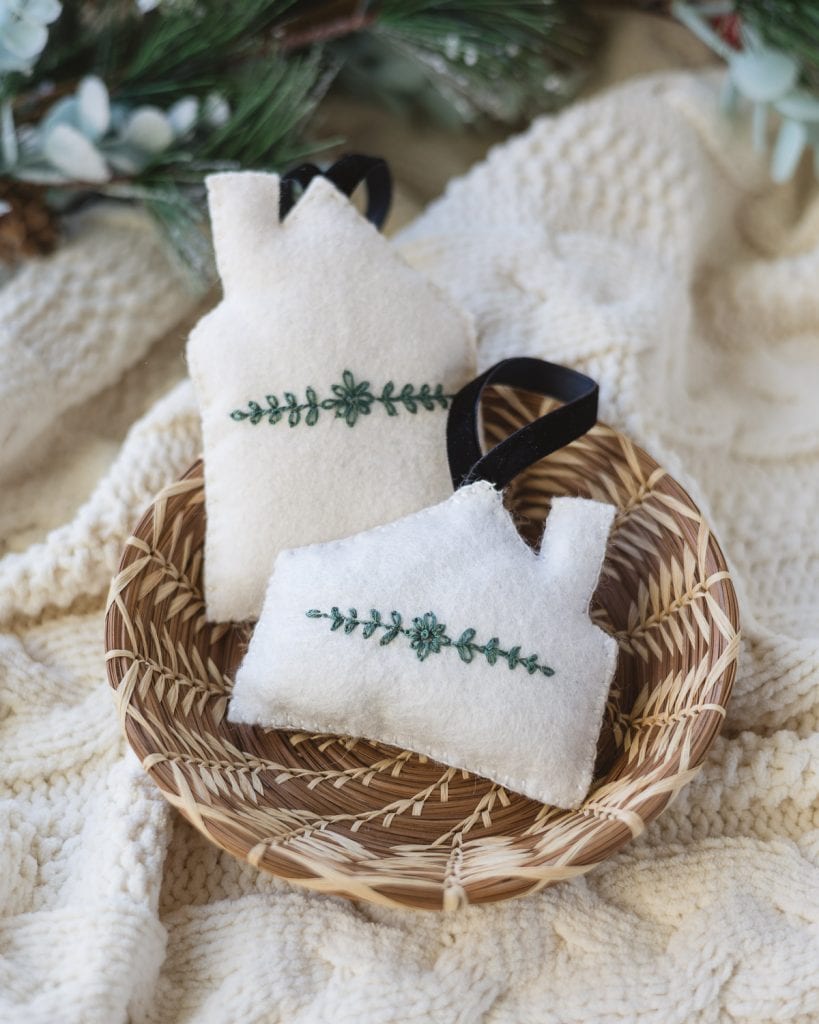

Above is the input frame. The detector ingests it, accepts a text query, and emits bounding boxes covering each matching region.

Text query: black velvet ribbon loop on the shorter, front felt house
[446,356,598,489]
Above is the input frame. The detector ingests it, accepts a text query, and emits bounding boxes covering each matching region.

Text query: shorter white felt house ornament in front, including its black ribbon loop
[228,359,617,808]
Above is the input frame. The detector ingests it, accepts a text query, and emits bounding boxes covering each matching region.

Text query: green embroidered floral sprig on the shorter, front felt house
[305,607,555,676]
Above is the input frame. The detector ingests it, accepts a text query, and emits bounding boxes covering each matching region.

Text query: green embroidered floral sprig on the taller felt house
[230,370,455,427]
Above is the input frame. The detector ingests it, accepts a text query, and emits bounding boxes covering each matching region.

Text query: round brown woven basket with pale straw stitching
[105,389,738,909]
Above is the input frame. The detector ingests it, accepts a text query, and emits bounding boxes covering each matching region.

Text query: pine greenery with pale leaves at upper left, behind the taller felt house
[0,0,593,278]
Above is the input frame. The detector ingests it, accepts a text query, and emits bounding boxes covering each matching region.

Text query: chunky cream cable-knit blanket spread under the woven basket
[0,75,819,1024]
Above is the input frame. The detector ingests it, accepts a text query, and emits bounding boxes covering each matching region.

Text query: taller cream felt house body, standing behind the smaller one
[187,172,475,621]
